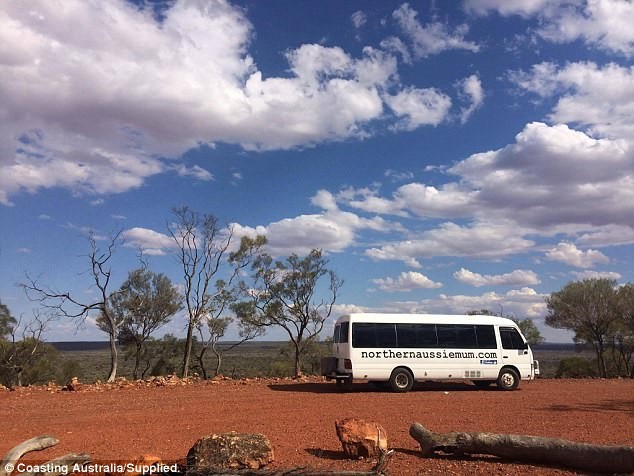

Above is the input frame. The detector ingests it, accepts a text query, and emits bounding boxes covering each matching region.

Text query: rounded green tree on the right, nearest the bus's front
[546,278,620,377]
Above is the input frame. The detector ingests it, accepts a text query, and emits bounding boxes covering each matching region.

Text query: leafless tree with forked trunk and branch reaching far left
[20,231,121,382]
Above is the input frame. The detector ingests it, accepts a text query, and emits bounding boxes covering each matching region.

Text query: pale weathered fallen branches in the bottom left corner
[0,435,90,476]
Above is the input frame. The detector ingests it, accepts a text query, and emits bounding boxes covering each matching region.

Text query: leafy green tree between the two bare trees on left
[97,267,182,379]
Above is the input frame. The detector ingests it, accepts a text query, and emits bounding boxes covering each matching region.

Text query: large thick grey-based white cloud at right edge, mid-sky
[449,123,634,233]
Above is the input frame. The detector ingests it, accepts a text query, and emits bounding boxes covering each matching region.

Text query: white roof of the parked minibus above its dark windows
[337,312,517,327]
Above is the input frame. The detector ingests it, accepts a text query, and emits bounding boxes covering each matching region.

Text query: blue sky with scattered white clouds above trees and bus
[0,0,634,341]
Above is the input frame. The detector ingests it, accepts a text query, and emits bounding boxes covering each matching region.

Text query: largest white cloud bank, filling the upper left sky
[0,0,460,205]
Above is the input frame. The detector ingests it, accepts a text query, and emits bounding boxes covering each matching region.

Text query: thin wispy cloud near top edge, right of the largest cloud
[392,3,479,59]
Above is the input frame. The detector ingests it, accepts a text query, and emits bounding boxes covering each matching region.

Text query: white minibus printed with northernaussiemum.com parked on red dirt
[322,314,539,392]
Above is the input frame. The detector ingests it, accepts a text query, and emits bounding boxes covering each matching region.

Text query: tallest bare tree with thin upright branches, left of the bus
[168,207,266,377]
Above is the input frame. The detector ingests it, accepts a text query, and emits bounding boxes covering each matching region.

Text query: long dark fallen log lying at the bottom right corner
[409,423,634,473]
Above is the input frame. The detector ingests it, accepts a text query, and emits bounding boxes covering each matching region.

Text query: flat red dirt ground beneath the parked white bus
[0,380,634,476]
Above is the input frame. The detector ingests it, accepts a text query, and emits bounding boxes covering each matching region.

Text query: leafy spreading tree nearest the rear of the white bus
[233,249,343,376]
